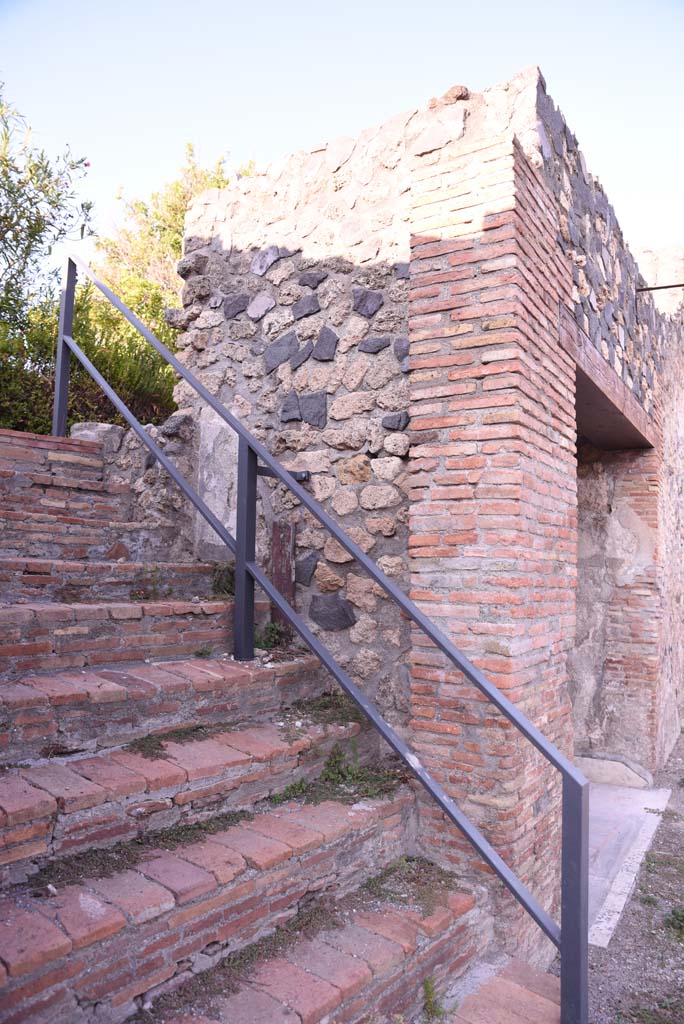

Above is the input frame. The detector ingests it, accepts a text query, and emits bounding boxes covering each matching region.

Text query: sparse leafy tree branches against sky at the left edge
[0,83,92,338]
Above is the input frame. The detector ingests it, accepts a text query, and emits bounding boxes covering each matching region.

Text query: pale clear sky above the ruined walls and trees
[0,0,684,246]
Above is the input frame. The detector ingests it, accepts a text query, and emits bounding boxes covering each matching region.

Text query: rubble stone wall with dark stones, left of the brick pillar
[169,113,418,721]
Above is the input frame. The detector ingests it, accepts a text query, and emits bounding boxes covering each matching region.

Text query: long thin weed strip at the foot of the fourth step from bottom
[29,811,254,895]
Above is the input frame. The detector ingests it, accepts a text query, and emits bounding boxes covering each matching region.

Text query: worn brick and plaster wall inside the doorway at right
[571,444,664,781]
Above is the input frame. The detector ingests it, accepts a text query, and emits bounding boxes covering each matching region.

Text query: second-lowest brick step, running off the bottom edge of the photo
[160,890,481,1024]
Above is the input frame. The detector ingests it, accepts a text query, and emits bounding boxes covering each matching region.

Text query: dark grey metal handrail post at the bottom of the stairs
[560,776,589,1024]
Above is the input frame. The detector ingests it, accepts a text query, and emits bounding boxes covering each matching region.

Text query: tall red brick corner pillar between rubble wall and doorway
[410,135,575,948]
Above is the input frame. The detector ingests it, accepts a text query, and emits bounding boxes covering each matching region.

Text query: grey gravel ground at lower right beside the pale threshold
[590,733,684,1024]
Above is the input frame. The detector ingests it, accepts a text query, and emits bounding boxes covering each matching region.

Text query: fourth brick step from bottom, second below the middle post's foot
[0,713,378,883]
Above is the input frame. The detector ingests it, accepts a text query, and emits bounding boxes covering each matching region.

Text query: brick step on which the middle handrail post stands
[0,651,323,764]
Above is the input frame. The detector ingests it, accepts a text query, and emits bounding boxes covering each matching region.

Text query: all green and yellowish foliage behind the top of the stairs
[0,89,235,433]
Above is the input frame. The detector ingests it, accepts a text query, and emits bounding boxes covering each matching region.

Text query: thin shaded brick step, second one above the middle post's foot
[0,558,222,604]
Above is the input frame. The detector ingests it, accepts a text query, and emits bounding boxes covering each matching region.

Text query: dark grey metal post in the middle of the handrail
[234,437,257,662]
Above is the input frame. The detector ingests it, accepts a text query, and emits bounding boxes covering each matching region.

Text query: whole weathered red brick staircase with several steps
[0,431,559,1024]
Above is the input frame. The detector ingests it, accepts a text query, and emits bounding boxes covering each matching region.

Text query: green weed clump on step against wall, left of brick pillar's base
[269,743,409,806]
